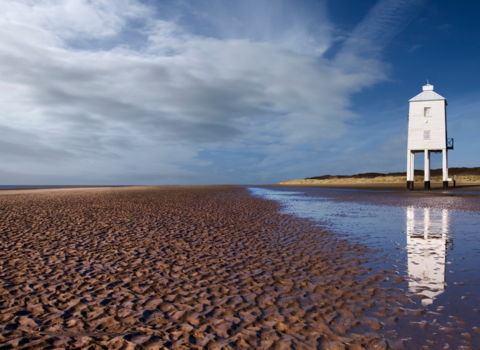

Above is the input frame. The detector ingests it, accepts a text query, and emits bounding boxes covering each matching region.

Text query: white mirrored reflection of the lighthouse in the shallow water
[407,207,449,305]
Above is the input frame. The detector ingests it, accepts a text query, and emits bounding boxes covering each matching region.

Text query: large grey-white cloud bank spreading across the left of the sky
[0,0,424,184]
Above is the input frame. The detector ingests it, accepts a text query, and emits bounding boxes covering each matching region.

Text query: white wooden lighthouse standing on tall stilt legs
[407,84,453,190]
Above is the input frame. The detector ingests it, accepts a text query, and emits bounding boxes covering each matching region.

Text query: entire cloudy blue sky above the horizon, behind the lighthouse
[0,0,480,185]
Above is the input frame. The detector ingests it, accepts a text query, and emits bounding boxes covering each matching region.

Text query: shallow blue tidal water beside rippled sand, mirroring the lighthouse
[248,187,480,348]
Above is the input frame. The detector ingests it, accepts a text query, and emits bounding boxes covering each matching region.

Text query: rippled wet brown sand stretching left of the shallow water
[0,186,480,349]
